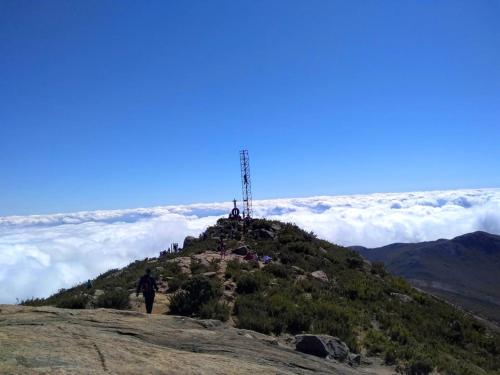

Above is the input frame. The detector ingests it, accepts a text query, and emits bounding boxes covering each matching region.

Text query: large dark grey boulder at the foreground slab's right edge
[295,335,349,362]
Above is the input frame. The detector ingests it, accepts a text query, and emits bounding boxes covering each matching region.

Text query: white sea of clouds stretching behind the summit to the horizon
[0,189,500,303]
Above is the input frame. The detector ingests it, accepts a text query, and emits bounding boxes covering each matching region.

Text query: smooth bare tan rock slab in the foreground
[0,305,392,374]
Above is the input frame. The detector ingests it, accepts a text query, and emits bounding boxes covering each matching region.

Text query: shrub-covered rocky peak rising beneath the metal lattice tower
[24,219,500,374]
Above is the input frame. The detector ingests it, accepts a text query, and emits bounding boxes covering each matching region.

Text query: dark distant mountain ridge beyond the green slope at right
[351,232,500,323]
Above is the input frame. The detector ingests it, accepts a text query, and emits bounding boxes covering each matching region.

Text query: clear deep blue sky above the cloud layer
[0,0,500,215]
